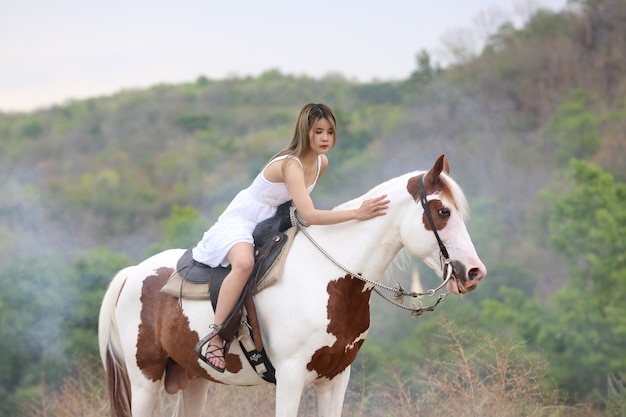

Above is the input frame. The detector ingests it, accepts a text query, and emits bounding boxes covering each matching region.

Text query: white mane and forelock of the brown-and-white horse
[335,171,469,221]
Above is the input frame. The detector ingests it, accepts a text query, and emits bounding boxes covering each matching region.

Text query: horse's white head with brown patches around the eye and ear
[402,155,487,294]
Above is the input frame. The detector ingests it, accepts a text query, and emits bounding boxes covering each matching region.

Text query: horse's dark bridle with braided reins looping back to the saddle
[289,175,454,318]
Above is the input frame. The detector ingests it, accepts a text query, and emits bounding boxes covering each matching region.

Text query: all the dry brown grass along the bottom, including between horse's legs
[23,323,601,417]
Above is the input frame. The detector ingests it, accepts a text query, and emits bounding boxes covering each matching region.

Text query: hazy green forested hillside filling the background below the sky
[0,0,626,417]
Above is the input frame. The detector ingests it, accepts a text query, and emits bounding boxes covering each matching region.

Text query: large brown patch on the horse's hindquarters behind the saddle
[136,268,243,385]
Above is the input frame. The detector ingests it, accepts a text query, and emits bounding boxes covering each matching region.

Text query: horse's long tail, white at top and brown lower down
[98,266,134,417]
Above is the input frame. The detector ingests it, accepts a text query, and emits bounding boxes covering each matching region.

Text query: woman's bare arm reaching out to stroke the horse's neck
[282,158,389,225]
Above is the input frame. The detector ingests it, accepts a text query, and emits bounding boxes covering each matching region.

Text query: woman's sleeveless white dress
[192,155,322,267]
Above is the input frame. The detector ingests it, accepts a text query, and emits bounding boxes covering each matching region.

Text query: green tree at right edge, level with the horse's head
[550,160,626,301]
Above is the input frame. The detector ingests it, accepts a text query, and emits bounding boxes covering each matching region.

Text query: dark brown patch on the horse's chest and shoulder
[307,274,371,379]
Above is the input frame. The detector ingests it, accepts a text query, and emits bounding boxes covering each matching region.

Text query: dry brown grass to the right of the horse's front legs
[368,323,600,417]
